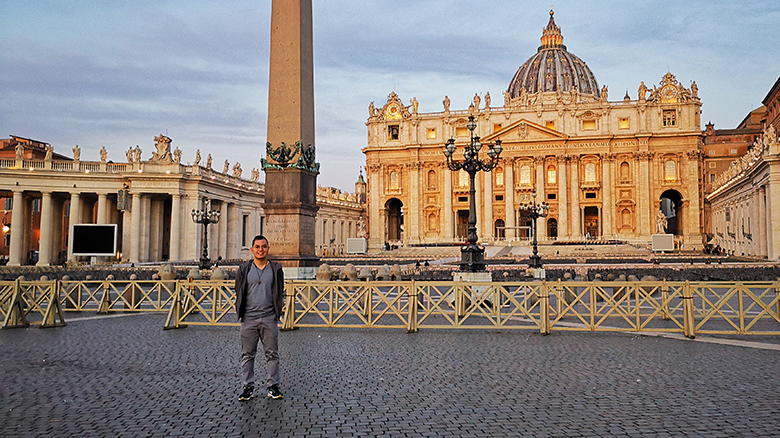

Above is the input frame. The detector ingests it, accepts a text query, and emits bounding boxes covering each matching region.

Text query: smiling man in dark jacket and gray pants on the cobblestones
[236,236,284,401]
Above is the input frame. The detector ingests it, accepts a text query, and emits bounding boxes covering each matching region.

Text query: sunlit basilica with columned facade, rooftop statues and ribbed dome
[363,12,703,251]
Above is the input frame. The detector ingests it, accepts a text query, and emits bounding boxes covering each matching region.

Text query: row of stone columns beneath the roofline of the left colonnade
[8,190,261,266]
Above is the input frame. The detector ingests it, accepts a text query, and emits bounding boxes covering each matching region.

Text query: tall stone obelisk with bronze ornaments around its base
[262,0,319,279]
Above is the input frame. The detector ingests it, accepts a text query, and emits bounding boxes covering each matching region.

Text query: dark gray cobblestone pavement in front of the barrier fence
[0,314,780,437]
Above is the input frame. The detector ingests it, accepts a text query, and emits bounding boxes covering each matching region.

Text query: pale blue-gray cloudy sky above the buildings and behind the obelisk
[0,0,780,191]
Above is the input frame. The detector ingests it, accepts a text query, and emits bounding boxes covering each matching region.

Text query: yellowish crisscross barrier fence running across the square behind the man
[0,280,780,338]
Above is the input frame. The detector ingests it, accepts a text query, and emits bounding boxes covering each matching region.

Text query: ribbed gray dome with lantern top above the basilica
[508,11,599,98]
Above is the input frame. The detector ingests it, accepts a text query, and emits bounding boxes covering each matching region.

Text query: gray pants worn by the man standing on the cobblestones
[241,315,279,387]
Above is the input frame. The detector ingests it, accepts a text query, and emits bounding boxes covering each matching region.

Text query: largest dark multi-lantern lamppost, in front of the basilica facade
[444,116,504,272]
